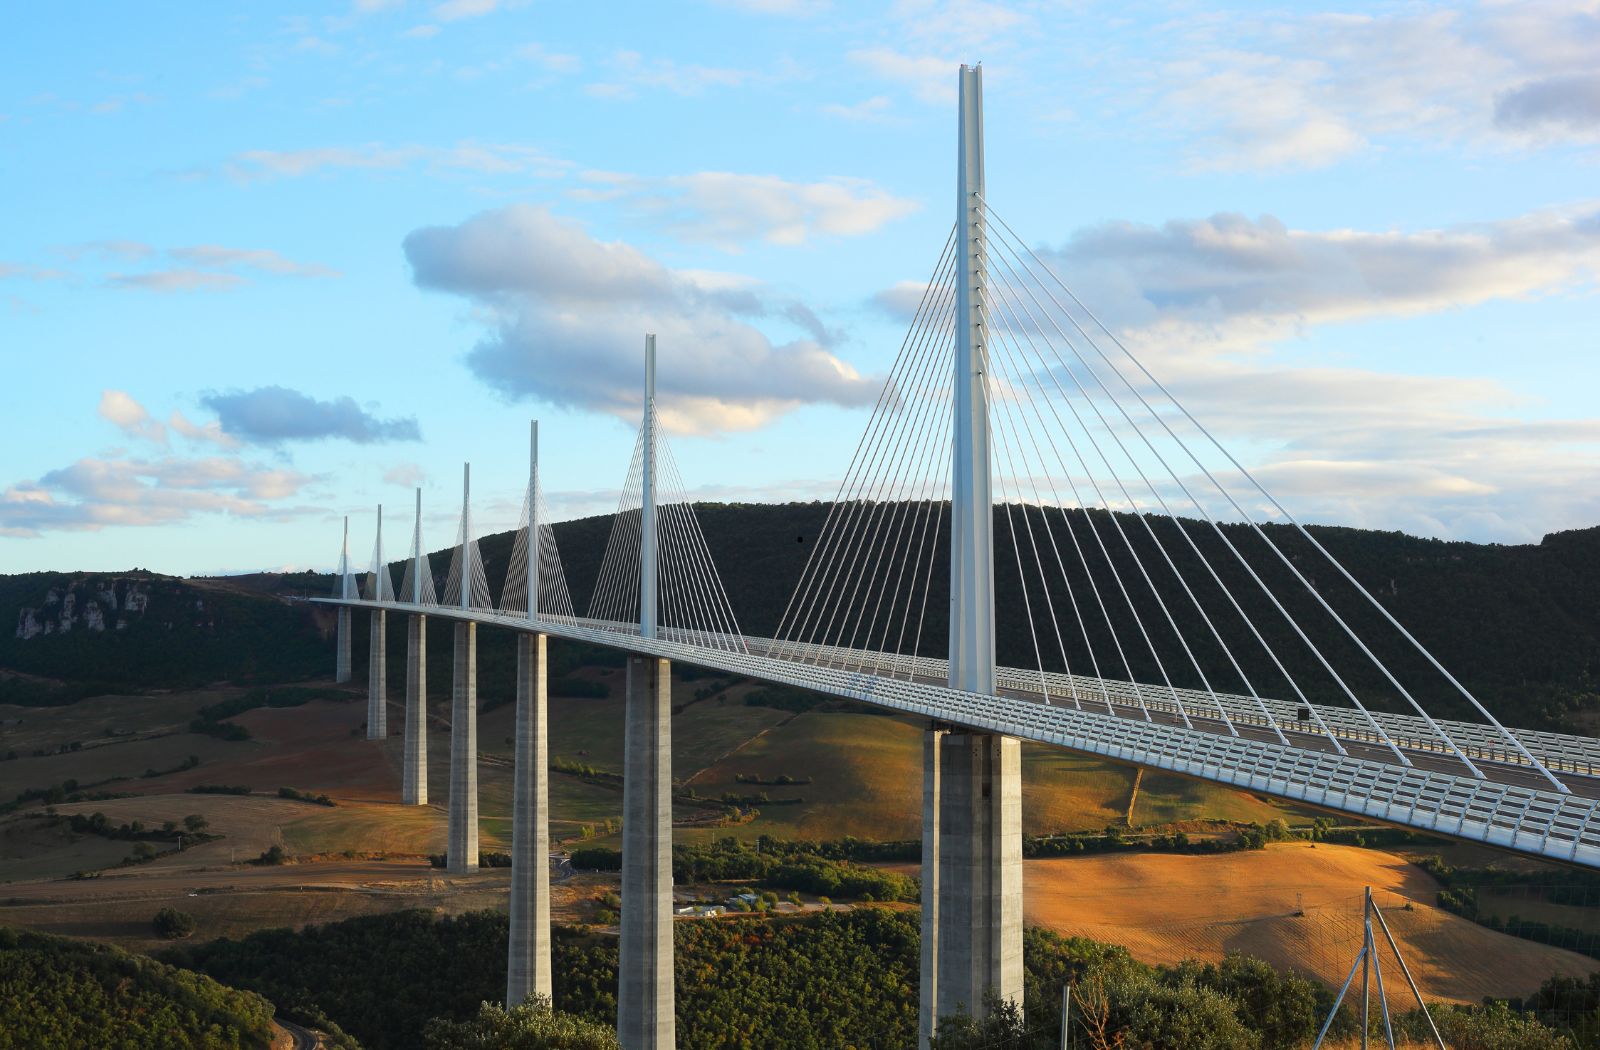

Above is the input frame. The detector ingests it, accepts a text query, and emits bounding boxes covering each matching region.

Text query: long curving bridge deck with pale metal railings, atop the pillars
[315,599,1600,868]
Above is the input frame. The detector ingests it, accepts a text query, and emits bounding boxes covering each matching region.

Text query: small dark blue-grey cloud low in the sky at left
[200,386,422,445]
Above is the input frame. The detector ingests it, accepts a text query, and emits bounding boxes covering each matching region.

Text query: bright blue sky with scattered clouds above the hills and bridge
[0,0,1600,573]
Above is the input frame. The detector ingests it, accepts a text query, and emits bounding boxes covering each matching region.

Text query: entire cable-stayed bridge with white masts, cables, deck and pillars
[305,67,1600,1050]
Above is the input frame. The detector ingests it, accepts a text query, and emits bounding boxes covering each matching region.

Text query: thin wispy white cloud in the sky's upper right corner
[1150,3,1600,170]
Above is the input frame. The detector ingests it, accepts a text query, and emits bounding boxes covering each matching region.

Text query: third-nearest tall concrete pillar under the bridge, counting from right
[506,634,550,1007]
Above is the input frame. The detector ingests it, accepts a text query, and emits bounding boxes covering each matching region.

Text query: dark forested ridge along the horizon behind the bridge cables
[0,503,1600,731]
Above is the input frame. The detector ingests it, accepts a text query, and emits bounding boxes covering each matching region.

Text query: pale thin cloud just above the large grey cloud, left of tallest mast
[573,171,917,248]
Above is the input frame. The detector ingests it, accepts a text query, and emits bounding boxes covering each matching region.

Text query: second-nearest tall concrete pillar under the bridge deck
[616,656,675,1050]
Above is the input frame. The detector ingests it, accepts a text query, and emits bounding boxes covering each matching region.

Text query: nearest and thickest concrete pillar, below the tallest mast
[925,731,1022,1016]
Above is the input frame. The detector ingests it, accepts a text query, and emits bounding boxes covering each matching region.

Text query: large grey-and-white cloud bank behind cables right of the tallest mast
[874,203,1600,541]
